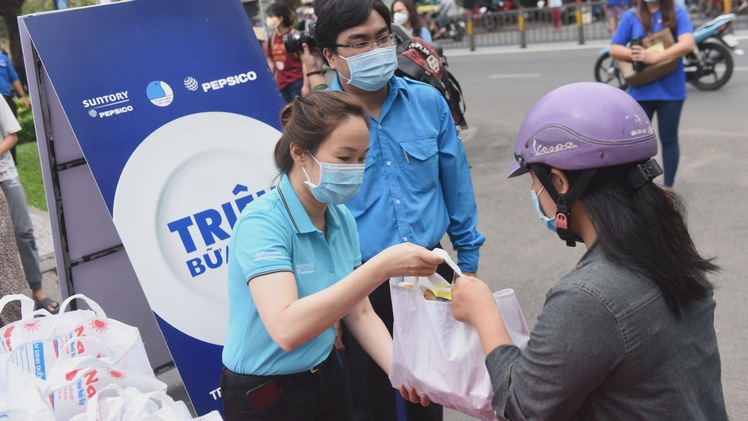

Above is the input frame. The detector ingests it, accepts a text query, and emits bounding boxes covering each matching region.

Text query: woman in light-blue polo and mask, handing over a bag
[221,91,442,421]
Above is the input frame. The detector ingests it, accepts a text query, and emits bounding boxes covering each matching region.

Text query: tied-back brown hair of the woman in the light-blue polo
[274,91,369,173]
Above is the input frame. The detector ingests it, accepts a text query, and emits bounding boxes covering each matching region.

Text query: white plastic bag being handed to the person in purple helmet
[390,248,530,420]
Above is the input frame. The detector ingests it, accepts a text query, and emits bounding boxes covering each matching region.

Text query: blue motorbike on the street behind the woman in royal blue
[595,13,744,91]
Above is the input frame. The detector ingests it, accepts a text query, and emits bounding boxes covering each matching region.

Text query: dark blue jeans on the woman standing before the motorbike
[639,101,683,187]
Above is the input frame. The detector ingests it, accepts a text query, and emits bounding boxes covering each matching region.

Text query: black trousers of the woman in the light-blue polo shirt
[221,351,353,421]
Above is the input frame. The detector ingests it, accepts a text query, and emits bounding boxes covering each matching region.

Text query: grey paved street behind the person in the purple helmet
[445,33,748,421]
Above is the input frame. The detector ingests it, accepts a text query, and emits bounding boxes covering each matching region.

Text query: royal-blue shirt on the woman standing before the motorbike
[611,5,693,101]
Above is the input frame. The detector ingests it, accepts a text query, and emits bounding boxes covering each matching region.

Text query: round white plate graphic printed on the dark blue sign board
[113,112,281,345]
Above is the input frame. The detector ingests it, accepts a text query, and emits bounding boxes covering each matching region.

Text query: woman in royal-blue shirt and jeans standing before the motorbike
[610,0,696,189]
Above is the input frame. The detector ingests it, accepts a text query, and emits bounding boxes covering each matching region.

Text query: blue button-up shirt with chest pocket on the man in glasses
[330,75,485,272]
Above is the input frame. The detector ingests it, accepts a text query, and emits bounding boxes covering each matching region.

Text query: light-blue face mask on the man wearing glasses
[338,45,397,92]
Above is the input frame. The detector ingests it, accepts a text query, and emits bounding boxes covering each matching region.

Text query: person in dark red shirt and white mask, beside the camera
[265,3,304,103]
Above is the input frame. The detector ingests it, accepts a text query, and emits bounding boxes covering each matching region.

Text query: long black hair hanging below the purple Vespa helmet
[565,163,719,315]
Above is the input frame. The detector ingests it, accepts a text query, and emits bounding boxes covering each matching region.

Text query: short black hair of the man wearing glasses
[314,0,392,51]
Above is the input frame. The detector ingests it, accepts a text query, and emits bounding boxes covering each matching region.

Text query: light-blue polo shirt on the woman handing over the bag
[223,174,361,376]
